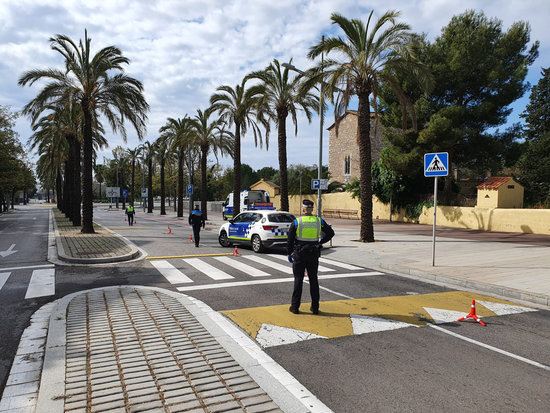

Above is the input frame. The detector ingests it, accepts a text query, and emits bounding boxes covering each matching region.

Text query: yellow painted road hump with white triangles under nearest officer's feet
[222,291,528,338]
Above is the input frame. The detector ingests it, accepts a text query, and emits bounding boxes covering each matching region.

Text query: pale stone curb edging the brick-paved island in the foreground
[36,285,331,413]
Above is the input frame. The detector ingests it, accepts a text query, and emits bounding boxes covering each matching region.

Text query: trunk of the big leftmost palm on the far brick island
[81,101,95,234]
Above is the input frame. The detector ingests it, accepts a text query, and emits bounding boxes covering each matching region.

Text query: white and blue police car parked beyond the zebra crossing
[218,210,295,252]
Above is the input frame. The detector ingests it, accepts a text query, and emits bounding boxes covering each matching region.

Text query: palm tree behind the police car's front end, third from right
[210,77,269,215]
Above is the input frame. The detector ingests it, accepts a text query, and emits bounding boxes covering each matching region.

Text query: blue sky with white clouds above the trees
[0,0,550,169]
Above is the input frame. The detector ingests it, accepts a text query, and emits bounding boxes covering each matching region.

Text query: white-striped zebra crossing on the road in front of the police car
[149,254,382,291]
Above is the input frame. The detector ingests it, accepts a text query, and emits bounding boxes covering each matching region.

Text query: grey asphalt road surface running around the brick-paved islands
[0,204,550,412]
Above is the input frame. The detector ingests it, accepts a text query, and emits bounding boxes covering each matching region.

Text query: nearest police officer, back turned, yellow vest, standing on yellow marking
[287,199,334,314]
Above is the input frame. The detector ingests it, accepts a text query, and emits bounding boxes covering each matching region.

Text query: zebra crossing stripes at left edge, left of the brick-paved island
[0,264,55,300]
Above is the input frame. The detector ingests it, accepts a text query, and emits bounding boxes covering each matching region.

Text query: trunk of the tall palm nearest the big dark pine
[357,92,374,242]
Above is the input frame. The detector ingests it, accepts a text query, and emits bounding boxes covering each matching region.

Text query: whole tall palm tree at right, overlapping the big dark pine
[308,10,423,242]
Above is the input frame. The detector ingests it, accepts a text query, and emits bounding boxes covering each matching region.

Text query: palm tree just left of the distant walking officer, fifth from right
[159,115,193,217]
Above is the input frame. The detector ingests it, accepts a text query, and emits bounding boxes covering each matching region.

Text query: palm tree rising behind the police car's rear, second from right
[249,59,319,211]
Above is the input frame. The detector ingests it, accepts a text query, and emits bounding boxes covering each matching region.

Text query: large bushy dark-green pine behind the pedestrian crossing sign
[381,11,538,206]
